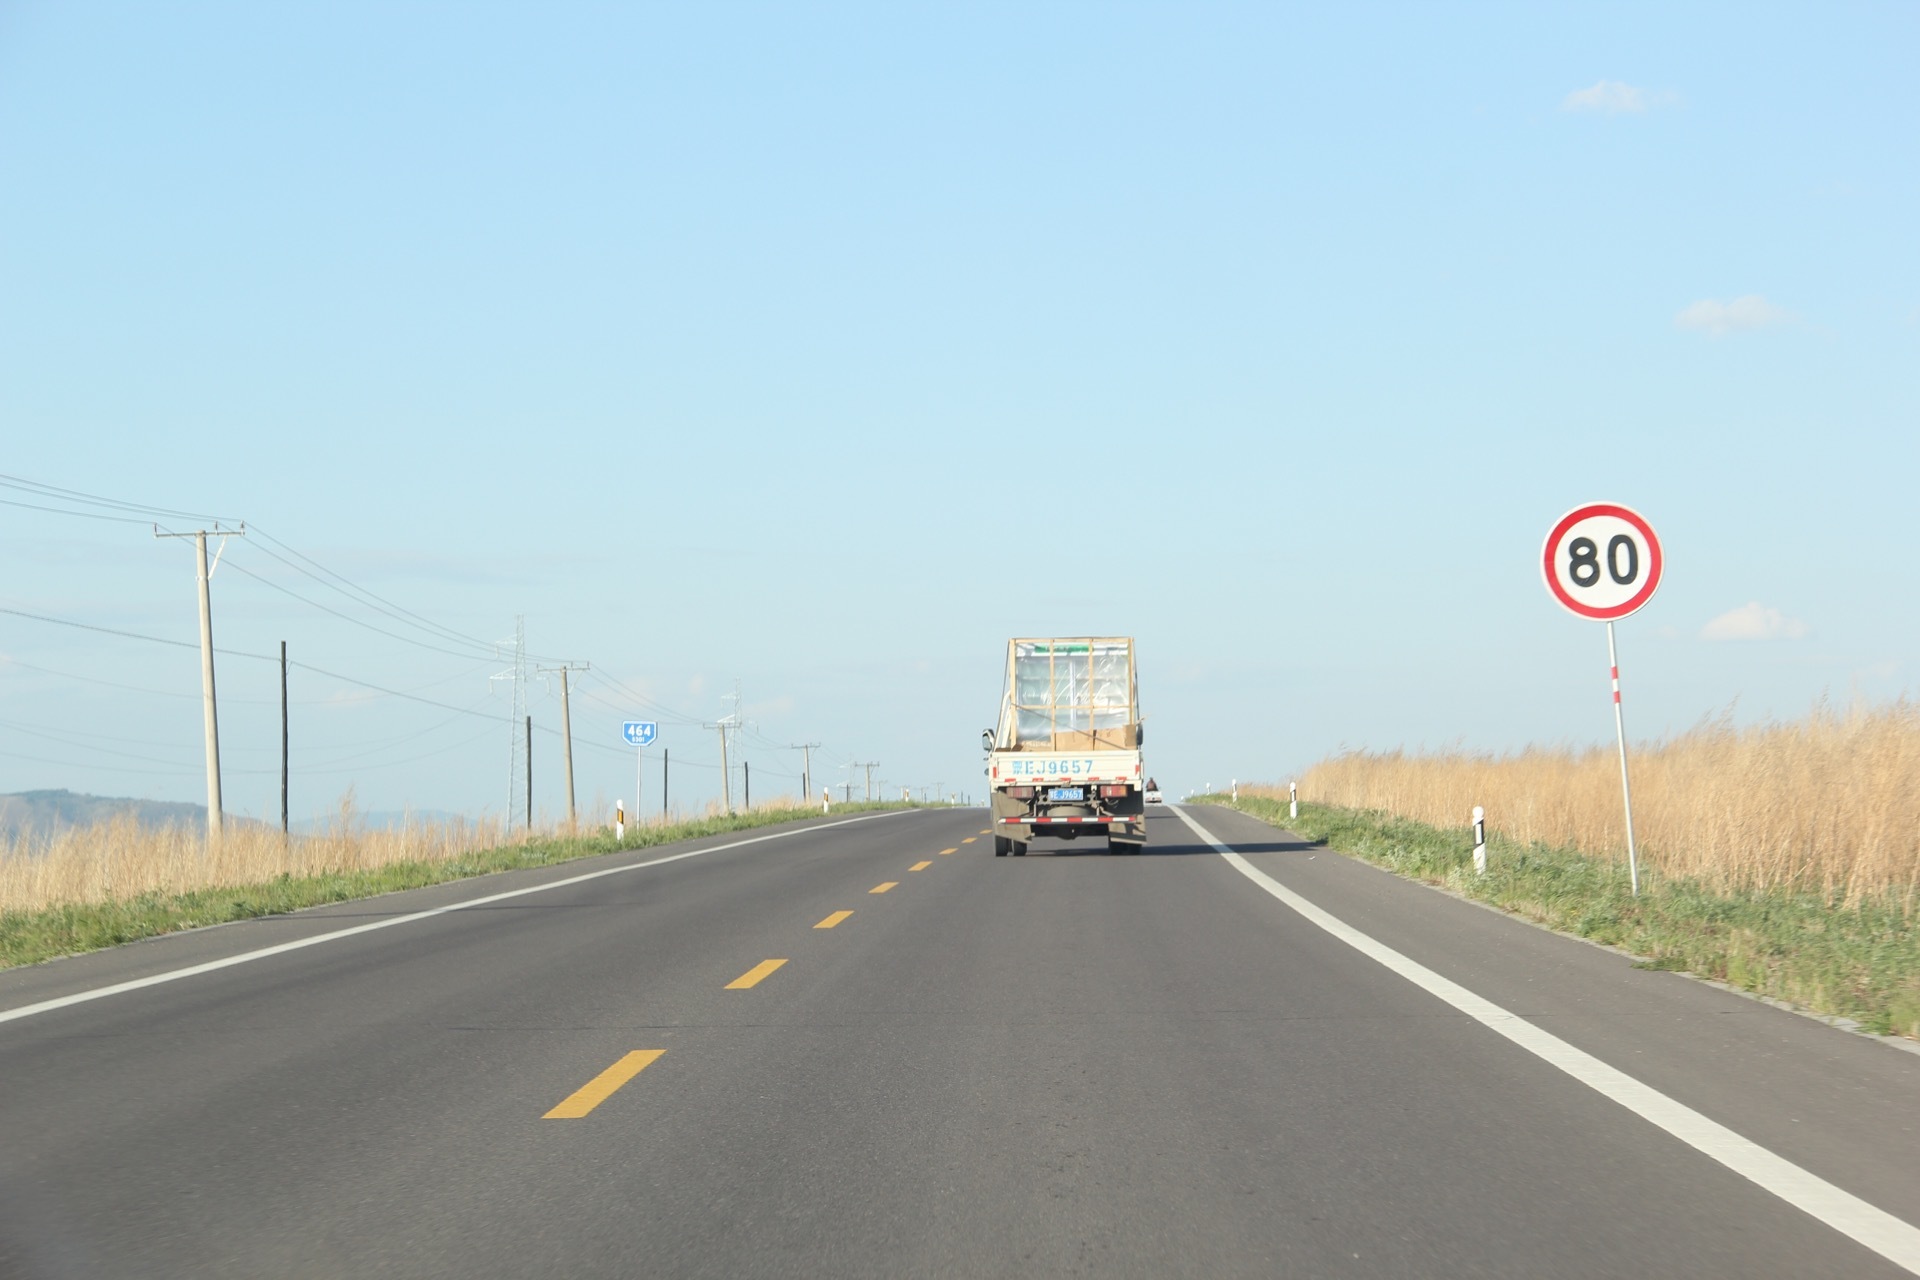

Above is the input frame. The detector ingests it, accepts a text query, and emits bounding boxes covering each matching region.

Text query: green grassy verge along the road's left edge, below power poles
[0,802,912,967]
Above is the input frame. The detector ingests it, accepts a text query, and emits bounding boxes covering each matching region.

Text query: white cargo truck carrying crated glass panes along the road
[981,635,1146,858]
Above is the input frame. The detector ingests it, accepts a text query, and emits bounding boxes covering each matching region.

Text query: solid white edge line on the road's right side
[1167,804,1920,1276]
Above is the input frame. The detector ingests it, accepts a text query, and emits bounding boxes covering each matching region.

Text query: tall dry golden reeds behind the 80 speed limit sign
[1269,699,1920,912]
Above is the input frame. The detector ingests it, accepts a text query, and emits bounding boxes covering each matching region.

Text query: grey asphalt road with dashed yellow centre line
[0,808,1920,1278]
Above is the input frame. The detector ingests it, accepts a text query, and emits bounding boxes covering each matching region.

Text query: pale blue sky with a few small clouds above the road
[0,4,1920,816]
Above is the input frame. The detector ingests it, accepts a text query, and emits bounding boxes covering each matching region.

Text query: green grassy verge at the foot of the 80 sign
[1196,796,1920,1040]
